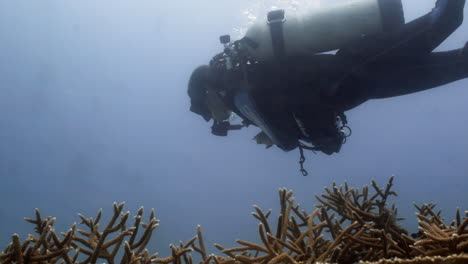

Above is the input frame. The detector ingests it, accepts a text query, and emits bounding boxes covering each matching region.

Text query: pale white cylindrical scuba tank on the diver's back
[245,0,404,61]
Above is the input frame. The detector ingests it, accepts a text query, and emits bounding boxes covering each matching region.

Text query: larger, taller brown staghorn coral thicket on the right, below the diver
[213,177,468,264]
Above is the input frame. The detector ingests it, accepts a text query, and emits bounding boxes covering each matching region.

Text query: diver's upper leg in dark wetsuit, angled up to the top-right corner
[337,0,466,62]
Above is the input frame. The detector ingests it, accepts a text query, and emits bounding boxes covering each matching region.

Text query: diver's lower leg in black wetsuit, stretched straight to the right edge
[328,46,468,111]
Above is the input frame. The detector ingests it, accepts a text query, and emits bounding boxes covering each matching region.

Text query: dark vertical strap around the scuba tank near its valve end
[267,9,286,61]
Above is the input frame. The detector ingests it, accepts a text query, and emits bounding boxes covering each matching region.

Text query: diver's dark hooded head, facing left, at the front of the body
[187,65,211,121]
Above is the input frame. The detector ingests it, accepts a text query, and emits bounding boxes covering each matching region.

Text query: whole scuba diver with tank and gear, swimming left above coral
[188,0,468,175]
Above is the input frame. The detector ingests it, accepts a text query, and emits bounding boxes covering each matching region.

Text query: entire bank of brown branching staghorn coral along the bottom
[0,177,468,264]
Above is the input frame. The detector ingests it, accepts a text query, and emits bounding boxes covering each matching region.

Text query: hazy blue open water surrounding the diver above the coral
[0,0,468,256]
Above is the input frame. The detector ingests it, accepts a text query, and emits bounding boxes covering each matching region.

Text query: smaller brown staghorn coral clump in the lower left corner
[0,203,191,264]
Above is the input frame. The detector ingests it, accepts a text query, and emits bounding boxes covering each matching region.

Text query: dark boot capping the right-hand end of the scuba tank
[378,0,405,32]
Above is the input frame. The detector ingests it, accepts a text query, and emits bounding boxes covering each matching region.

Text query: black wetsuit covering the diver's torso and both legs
[241,0,468,154]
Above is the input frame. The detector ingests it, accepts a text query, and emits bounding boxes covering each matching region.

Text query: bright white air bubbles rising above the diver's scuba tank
[231,0,320,39]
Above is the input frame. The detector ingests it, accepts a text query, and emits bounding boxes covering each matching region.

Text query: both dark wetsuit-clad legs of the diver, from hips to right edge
[330,0,468,110]
